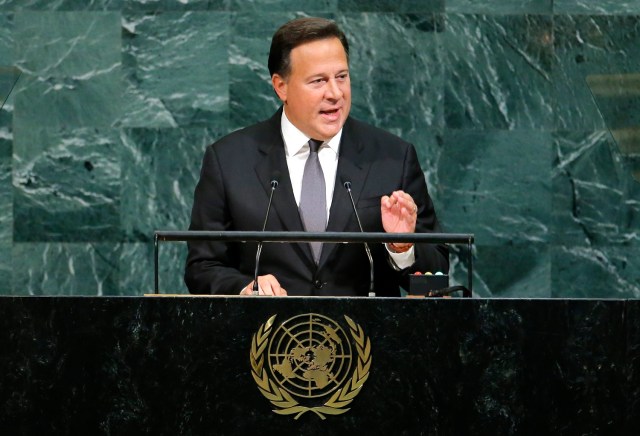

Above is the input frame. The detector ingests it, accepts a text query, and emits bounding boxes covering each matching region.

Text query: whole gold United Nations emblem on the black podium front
[250,313,371,419]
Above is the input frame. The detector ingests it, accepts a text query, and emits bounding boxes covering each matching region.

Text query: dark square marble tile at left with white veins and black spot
[13,128,121,242]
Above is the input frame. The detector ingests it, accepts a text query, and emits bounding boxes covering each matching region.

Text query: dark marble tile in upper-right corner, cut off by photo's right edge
[553,15,640,130]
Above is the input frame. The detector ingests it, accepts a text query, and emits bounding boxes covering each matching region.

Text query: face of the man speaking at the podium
[271,38,351,141]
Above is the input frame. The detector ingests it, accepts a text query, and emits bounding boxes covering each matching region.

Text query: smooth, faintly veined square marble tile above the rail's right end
[437,130,552,245]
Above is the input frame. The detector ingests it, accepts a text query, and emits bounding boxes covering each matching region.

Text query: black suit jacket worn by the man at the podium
[185,108,449,296]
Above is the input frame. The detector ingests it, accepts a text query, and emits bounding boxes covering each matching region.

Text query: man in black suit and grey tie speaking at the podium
[185,18,449,296]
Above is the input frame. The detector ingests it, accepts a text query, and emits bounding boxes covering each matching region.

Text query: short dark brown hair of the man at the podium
[268,17,349,77]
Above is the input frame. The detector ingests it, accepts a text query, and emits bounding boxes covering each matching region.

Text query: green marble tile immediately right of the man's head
[337,13,443,132]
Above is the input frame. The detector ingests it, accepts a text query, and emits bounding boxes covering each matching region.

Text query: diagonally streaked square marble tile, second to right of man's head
[443,14,553,130]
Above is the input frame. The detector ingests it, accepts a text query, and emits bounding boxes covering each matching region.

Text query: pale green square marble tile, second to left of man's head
[120,12,229,127]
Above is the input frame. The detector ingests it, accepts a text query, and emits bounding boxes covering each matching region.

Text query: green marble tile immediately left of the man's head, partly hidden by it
[229,12,304,130]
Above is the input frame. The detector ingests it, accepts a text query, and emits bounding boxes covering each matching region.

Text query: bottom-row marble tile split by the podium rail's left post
[119,242,189,295]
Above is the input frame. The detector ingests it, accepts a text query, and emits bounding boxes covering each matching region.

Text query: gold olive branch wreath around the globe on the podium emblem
[250,315,371,420]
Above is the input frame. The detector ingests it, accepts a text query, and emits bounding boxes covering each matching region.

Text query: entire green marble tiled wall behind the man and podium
[0,0,640,298]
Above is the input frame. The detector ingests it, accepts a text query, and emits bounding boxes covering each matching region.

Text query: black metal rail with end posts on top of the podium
[153,230,474,294]
